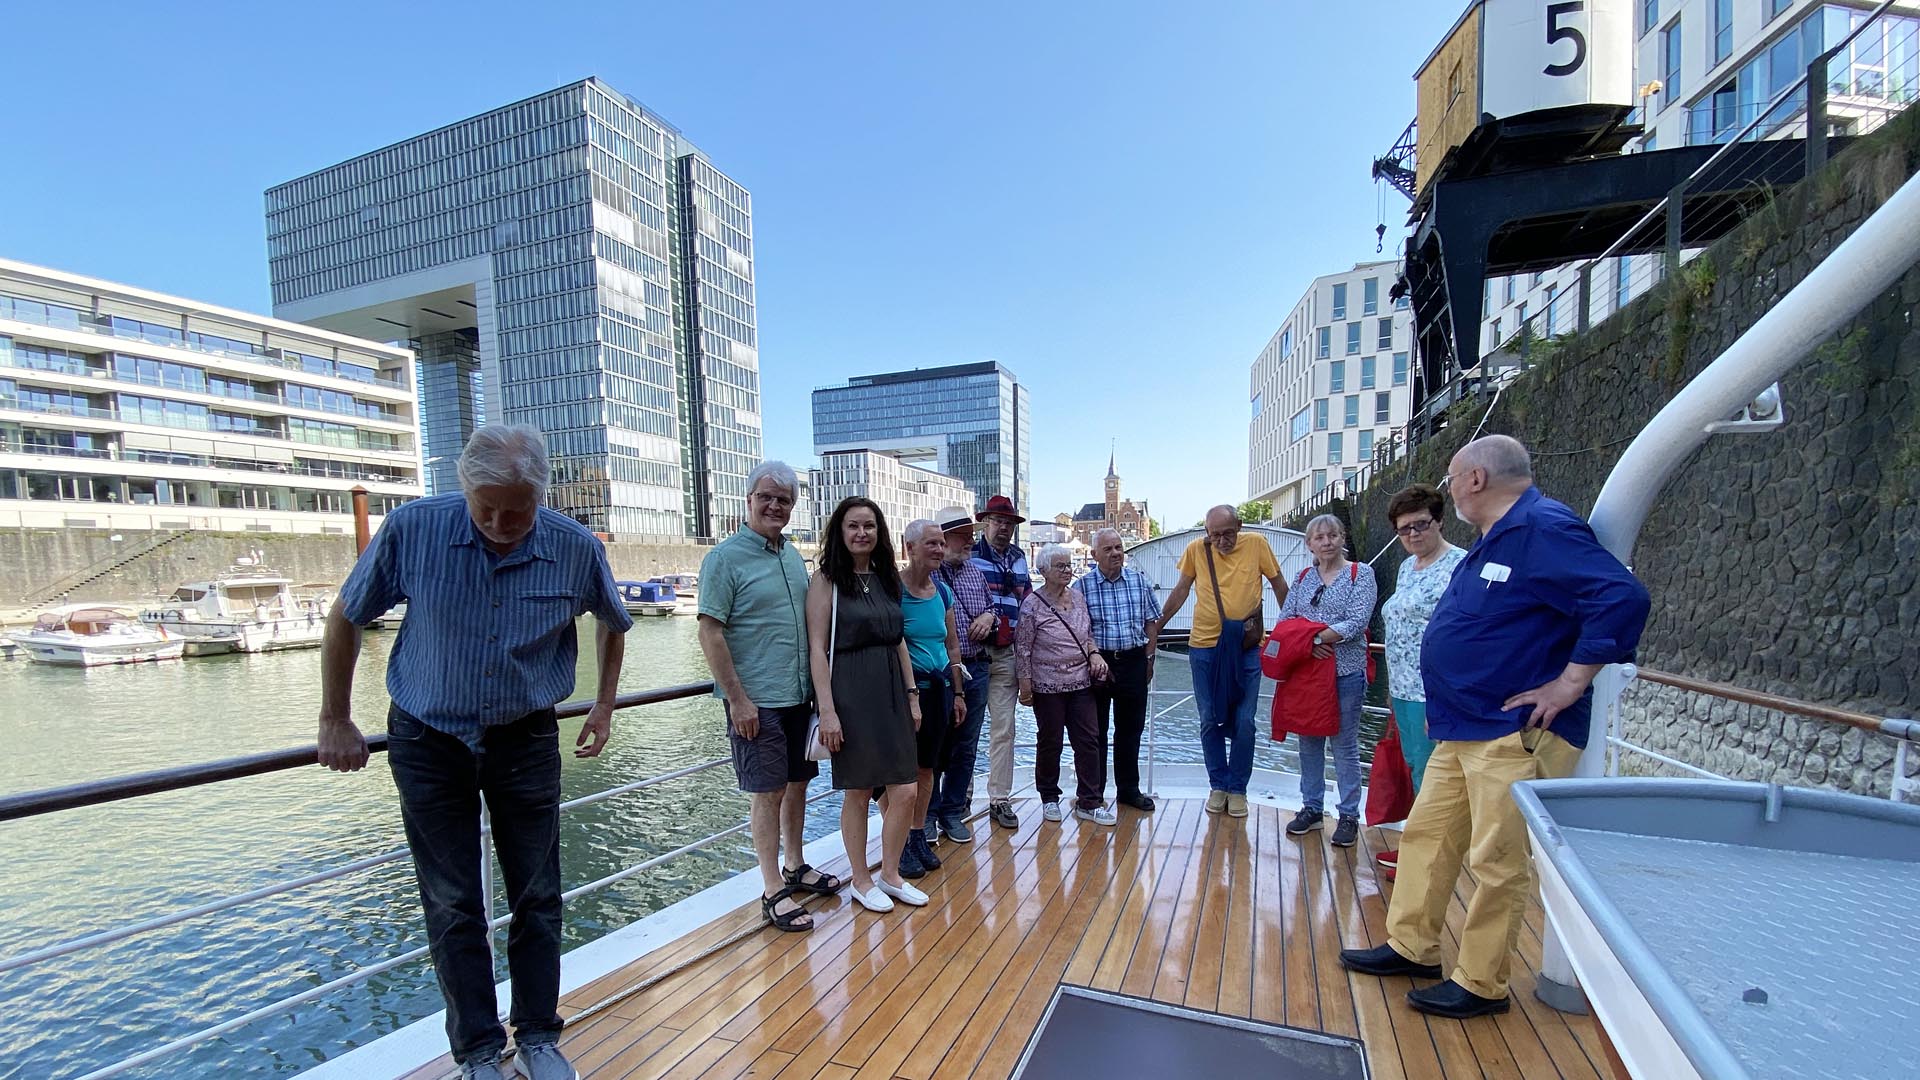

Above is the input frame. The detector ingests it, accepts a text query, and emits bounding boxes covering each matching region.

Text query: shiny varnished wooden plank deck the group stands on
[397,799,1605,1080]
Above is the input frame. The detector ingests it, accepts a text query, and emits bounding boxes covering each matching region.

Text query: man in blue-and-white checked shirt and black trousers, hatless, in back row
[1073,528,1160,811]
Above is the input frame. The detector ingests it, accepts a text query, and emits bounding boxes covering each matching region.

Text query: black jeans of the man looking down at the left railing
[386,709,561,1061]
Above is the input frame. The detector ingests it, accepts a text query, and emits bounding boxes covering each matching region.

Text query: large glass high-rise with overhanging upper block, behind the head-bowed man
[267,79,760,538]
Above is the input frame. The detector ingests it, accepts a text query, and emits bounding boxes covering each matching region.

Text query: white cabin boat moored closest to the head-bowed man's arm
[140,557,330,655]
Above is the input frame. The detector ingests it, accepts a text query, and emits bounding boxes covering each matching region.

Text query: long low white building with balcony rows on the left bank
[0,259,422,536]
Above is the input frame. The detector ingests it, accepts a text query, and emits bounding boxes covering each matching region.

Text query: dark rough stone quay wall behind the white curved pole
[1352,110,1920,794]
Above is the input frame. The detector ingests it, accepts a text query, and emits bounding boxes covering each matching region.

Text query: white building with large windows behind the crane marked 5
[1480,0,1920,356]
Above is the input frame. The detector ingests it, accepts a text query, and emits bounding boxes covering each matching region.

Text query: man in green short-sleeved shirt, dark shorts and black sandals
[699,461,841,932]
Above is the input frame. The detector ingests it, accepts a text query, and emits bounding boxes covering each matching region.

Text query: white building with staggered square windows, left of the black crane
[1246,261,1413,517]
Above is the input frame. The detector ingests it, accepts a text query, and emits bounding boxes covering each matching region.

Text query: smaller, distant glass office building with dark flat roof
[814,361,1033,517]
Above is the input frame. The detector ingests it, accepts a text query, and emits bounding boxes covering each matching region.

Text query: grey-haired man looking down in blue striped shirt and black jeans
[319,425,634,1080]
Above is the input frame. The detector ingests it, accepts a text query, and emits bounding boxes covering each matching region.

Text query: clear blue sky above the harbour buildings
[0,0,1461,527]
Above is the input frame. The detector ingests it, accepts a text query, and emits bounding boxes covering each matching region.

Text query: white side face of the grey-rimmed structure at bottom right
[1534,841,1699,1080]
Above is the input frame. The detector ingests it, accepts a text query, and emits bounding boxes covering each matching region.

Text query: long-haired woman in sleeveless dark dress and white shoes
[806,498,927,911]
